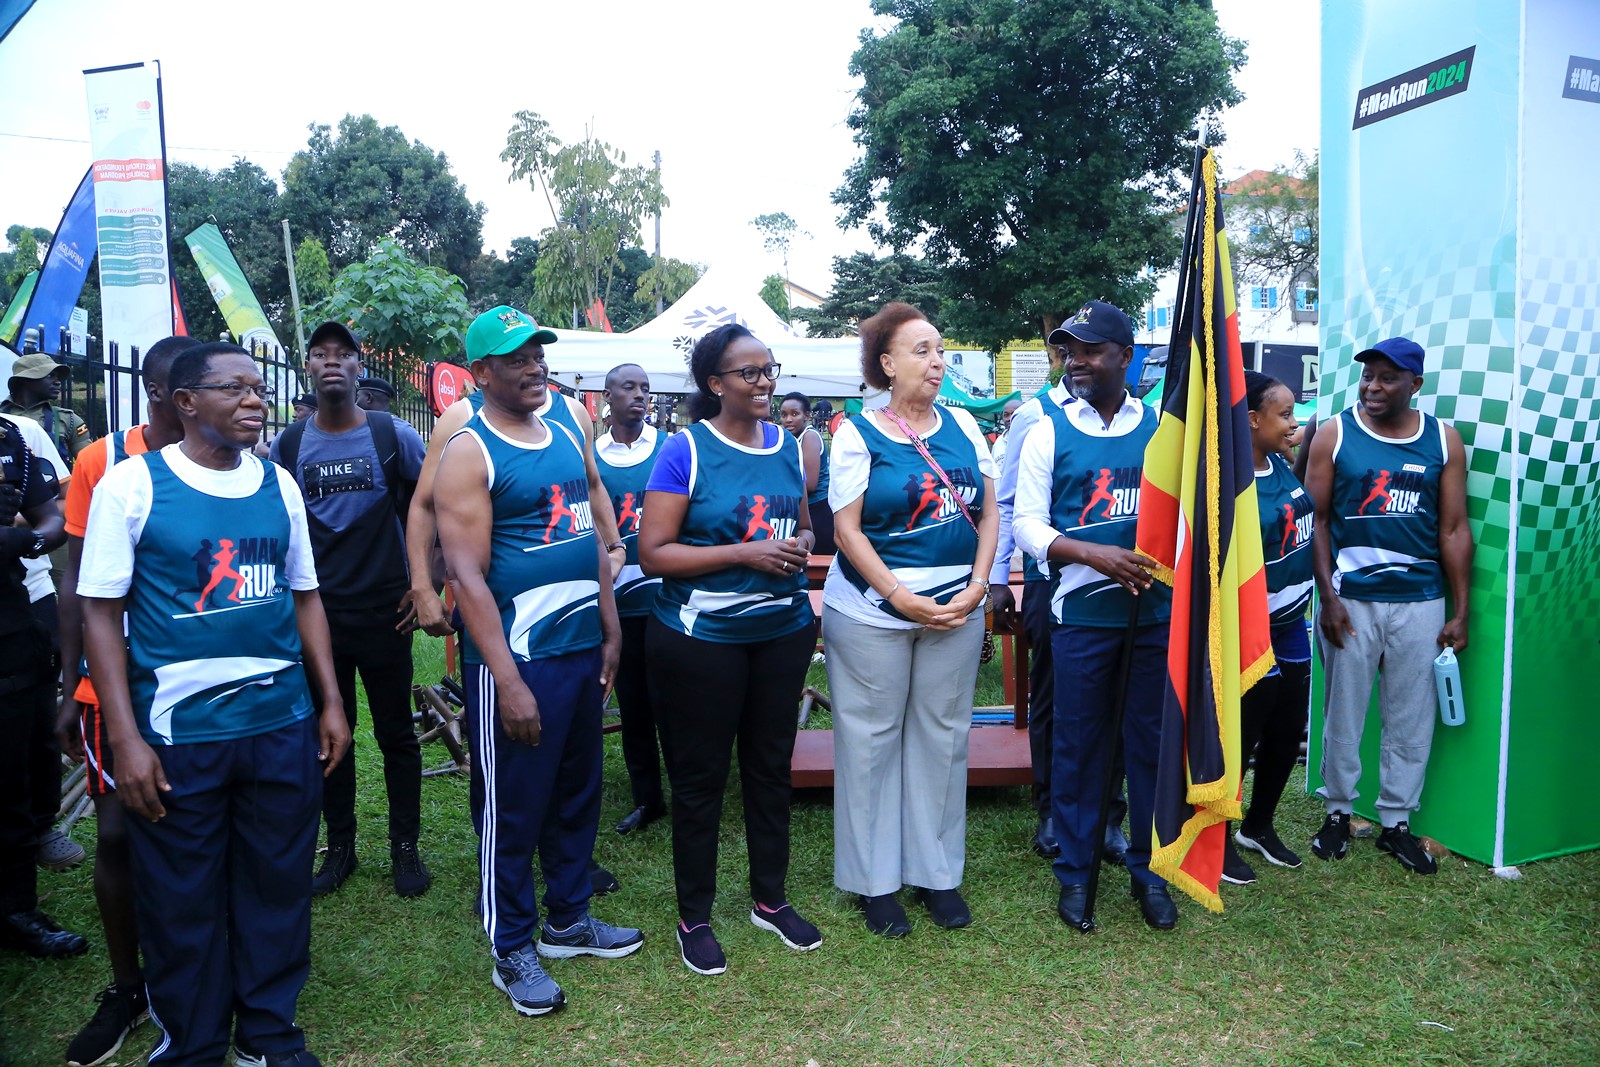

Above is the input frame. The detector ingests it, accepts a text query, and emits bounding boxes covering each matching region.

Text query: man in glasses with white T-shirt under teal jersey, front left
[77,344,350,1067]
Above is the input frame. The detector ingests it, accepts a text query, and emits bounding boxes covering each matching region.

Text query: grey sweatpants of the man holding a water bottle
[1317,598,1445,827]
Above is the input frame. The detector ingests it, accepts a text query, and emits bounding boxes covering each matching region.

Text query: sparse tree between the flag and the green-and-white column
[1227,154,1320,300]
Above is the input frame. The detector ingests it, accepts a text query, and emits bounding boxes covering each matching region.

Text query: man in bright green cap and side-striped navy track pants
[434,309,645,1016]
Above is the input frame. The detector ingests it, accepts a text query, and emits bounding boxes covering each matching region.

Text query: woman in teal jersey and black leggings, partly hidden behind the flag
[1222,371,1315,885]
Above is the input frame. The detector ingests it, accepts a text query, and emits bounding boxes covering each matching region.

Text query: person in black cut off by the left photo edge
[0,421,76,958]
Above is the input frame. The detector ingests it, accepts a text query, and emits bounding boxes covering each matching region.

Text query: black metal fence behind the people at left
[54,330,434,440]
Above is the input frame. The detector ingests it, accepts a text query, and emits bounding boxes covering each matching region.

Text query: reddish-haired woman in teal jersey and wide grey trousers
[822,302,1000,937]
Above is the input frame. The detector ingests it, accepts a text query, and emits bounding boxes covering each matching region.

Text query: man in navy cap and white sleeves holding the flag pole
[1013,301,1178,929]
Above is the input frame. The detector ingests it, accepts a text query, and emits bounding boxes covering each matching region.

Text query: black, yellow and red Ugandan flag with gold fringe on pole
[1138,149,1274,912]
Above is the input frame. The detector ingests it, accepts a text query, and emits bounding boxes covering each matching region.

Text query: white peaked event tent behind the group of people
[546,267,862,397]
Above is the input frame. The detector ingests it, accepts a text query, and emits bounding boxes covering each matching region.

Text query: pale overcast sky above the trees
[0,0,1320,293]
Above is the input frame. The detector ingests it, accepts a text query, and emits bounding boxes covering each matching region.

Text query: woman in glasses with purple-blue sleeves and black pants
[638,325,822,974]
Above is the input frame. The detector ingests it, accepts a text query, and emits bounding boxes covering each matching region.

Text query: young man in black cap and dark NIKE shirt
[272,322,432,896]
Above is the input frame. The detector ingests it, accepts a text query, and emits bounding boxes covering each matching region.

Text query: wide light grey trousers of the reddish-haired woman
[822,606,984,896]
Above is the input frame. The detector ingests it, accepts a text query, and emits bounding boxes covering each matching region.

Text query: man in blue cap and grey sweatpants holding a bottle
[1306,338,1472,875]
